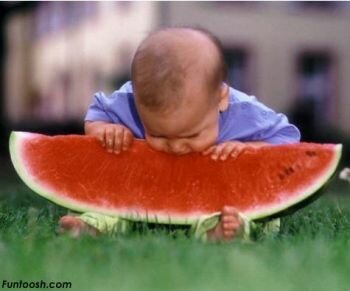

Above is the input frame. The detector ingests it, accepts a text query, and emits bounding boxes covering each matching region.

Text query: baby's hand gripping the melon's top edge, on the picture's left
[85,122,134,154]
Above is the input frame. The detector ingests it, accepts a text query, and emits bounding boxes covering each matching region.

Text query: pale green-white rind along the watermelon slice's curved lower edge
[9,132,342,225]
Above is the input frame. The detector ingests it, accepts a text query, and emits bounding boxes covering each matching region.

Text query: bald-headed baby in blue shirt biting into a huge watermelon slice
[59,28,300,240]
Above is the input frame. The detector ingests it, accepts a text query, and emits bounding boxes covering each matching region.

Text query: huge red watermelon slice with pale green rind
[10,132,342,224]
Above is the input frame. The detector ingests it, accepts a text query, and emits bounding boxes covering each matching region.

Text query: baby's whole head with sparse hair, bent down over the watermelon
[132,28,228,154]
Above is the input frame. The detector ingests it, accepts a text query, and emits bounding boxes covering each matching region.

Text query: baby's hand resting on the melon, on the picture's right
[203,141,246,161]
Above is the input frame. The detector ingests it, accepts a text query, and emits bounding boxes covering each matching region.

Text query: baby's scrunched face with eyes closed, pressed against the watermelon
[138,86,226,155]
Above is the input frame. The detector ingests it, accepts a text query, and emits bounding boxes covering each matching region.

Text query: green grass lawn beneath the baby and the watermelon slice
[0,171,350,291]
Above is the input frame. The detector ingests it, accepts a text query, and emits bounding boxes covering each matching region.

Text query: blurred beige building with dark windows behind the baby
[0,1,350,163]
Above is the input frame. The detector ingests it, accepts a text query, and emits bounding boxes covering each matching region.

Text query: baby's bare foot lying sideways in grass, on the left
[58,215,99,237]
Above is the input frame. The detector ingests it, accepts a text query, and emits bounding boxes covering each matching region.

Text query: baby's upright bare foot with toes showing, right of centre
[207,206,243,241]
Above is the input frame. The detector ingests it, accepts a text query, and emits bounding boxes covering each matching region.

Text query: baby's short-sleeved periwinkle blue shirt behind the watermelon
[85,81,300,144]
